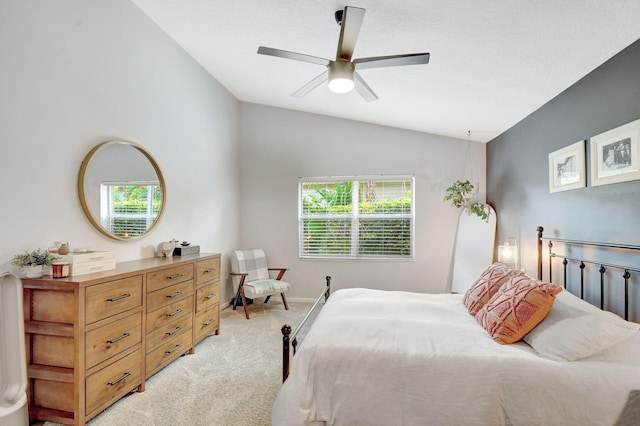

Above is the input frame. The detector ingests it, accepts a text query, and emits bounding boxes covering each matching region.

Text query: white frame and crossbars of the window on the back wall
[298,175,415,260]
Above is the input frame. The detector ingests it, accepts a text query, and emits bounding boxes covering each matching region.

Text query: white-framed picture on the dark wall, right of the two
[590,120,640,186]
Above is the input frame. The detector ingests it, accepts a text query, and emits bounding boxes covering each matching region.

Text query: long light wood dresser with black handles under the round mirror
[22,254,220,425]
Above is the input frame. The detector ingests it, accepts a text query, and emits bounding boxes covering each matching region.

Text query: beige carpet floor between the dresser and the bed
[45,298,311,426]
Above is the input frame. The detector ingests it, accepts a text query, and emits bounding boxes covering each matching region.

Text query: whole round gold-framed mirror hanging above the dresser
[78,140,166,241]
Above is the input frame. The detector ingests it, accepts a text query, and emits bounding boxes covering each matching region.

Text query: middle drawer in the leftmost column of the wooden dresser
[85,312,142,369]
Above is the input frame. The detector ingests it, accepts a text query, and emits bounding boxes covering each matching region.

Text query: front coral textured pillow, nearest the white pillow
[476,275,562,344]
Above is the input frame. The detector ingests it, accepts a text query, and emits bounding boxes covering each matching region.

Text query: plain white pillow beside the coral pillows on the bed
[524,291,640,361]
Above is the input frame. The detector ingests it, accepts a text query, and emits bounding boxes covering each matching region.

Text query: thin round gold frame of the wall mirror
[78,139,167,241]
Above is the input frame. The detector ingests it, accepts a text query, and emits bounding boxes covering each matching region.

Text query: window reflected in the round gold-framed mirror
[100,182,162,237]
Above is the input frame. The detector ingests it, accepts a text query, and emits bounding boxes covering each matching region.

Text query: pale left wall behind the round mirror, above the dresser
[0,0,240,298]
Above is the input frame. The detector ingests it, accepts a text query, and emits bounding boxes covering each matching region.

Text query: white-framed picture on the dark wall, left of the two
[549,140,587,193]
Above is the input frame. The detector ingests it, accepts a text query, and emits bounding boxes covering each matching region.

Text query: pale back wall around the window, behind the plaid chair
[240,103,485,298]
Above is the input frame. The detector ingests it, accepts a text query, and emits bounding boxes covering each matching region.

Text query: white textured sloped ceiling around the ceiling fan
[133,0,640,142]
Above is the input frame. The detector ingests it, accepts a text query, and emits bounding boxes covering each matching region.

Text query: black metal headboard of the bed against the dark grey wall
[537,226,640,320]
